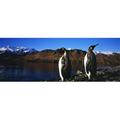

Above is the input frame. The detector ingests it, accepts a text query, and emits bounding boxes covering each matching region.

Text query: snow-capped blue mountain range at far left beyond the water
[0,45,37,54]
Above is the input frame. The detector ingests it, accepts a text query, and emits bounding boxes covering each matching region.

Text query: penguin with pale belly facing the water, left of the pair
[58,48,71,81]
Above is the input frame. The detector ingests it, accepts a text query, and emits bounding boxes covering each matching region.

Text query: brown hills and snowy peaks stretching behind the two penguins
[0,46,120,67]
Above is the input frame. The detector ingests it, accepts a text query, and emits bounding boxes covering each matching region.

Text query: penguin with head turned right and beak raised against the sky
[84,44,98,80]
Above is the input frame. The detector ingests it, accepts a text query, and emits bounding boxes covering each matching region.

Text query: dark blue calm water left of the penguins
[0,63,60,81]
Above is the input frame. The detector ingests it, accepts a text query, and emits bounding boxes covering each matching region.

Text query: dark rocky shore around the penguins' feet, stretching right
[69,66,120,82]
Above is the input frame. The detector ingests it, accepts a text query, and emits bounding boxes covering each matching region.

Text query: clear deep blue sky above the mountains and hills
[0,38,120,52]
